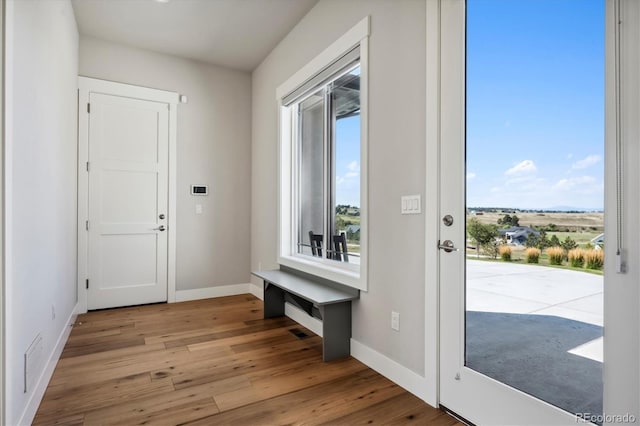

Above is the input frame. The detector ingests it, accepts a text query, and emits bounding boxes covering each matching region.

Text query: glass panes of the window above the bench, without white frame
[293,61,361,263]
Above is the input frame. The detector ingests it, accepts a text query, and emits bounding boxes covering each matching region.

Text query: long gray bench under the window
[252,269,360,361]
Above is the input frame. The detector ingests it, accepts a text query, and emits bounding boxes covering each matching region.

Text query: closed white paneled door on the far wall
[87,93,169,309]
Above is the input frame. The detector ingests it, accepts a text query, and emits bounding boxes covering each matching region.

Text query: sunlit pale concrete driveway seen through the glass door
[467,259,603,362]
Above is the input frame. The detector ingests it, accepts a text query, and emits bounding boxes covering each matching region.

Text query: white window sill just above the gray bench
[278,256,366,291]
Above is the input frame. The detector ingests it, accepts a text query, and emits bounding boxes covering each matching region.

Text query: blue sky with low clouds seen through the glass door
[467,0,604,209]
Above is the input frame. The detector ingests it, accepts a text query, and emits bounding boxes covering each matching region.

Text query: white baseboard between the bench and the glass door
[351,339,436,405]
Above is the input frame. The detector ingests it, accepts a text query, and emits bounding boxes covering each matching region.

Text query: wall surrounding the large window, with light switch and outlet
[251,0,429,374]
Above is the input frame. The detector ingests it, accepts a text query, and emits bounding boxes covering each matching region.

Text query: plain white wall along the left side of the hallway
[5,0,78,424]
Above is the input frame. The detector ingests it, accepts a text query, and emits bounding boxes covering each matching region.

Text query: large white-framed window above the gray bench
[278,20,368,289]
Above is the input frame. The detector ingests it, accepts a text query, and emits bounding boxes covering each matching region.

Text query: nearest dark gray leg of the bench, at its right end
[320,301,351,362]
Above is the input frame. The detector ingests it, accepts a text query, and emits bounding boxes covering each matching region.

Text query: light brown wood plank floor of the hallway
[34,295,460,425]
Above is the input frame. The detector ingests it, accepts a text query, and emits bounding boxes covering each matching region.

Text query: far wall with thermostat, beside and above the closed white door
[79,36,251,290]
